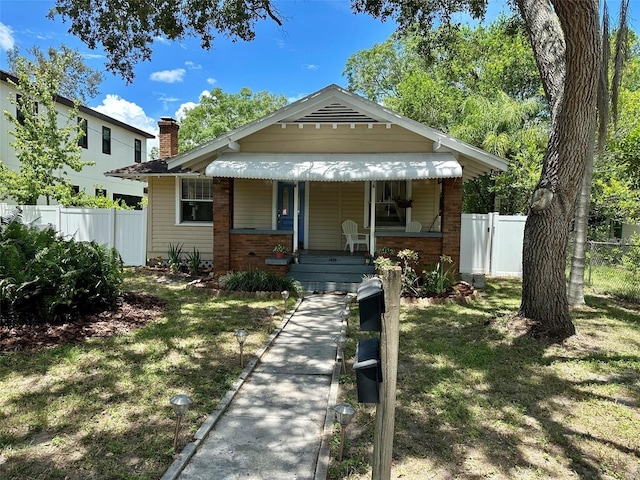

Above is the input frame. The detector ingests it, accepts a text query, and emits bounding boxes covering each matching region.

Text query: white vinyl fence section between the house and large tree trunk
[460,213,527,277]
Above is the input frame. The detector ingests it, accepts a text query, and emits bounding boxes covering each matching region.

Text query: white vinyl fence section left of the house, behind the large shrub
[0,203,147,266]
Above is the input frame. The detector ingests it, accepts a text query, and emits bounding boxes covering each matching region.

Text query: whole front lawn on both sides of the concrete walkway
[0,273,640,480]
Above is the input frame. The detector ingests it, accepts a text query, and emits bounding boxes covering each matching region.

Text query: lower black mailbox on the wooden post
[353,337,382,403]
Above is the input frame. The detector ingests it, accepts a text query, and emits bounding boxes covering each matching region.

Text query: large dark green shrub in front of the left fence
[0,222,123,323]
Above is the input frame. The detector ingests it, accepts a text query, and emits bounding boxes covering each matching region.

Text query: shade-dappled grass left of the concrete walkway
[0,273,282,480]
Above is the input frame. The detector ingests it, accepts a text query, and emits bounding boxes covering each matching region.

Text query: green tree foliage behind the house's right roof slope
[345,16,549,214]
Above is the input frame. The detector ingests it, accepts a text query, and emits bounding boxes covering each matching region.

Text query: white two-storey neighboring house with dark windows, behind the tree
[0,70,155,206]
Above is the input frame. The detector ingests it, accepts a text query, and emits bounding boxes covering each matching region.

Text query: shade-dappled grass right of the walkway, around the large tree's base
[329,279,640,480]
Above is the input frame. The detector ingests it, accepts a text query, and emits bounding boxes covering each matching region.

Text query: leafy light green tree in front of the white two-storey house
[0,48,95,205]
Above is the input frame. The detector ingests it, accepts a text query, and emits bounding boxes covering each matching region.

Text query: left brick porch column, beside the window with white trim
[213,178,232,275]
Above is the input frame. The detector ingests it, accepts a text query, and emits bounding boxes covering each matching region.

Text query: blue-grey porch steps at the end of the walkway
[287,251,375,292]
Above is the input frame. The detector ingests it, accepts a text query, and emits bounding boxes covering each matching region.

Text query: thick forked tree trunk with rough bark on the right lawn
[518,0,600,340]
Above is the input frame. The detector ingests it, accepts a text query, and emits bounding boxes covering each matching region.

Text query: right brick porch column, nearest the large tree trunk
[442,178,462,274]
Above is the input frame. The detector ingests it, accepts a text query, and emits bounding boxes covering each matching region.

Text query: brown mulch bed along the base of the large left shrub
[0,293,164,352]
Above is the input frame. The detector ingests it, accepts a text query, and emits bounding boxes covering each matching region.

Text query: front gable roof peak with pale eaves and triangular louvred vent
[167,84,507,176]
